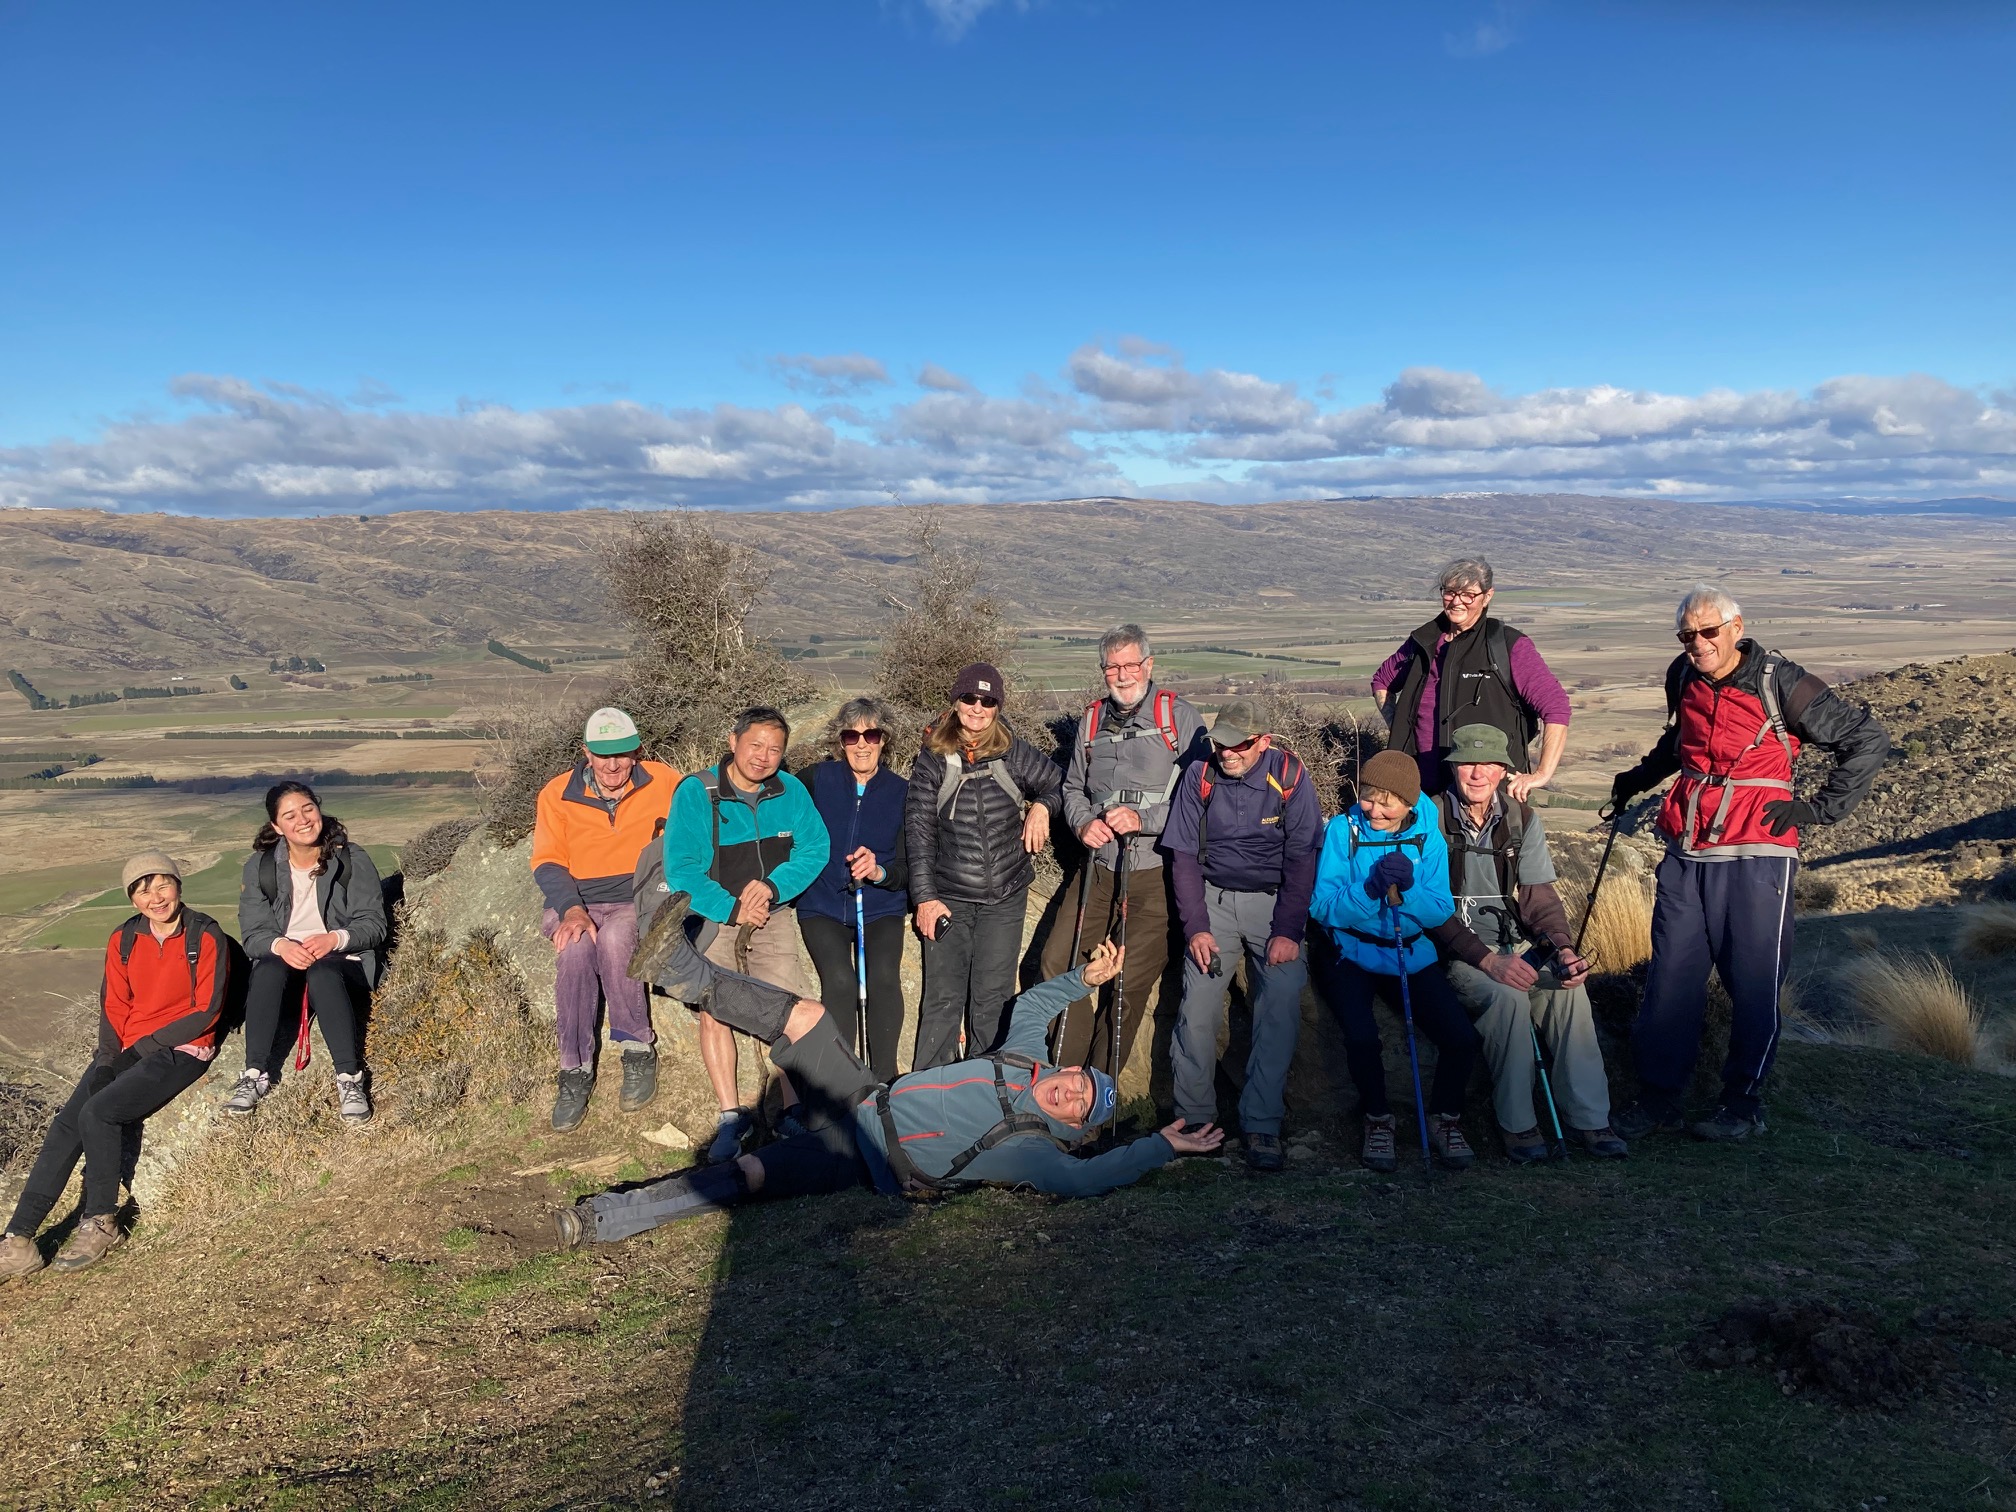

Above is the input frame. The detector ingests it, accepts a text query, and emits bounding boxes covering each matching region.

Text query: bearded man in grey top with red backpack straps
[1042,625,1206,1077]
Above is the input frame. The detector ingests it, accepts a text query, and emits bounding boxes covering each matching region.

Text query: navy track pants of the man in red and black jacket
[1631,851,1798,1115]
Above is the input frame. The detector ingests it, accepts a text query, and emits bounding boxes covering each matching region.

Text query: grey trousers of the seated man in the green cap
[1447,962,1611,1133]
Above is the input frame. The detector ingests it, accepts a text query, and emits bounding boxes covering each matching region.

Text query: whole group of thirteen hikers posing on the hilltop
[0,558,1889,1278]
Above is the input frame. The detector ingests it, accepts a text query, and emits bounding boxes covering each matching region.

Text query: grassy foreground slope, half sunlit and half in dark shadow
[0,1046,2016,1512]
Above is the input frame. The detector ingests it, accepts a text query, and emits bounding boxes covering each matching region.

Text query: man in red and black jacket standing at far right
[1611,585,1889,1139]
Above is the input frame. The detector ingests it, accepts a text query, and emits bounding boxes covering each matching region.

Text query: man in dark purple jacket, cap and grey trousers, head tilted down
[1161,702,1322,1171]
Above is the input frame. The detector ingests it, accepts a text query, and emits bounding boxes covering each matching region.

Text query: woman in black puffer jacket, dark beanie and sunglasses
[903,661,1062,1070]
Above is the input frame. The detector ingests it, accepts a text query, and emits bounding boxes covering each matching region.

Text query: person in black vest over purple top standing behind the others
[1373,556,1568,802]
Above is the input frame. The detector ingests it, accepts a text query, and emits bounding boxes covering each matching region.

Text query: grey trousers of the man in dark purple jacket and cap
[1169,883,1308,1135]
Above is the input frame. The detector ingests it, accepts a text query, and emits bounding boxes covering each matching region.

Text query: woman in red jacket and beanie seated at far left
[0,851,230,1280]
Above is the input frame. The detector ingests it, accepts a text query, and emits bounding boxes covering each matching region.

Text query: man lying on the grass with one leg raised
[554,893,1224,1248]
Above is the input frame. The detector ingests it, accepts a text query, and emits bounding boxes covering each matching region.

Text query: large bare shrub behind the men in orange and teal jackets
[490,514,814,845]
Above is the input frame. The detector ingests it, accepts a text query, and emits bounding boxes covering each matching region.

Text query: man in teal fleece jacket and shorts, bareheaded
[665,706,833,1161]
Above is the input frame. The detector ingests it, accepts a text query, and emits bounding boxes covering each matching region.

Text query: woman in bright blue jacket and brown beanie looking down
[1308,750,1482,1171]
